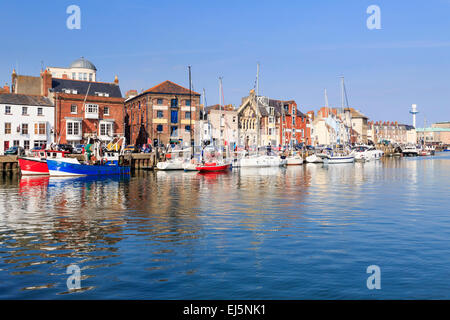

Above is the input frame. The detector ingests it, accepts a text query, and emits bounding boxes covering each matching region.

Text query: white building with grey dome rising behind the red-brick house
[47,57,97,82]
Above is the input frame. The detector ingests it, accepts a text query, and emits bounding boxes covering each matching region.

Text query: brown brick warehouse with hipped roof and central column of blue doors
[125,80,200,146]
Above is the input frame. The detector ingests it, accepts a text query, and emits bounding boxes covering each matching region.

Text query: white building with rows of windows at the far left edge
[0,93,55,154]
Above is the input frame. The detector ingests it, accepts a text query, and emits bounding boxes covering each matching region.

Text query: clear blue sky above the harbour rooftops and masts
[0,0,450,126]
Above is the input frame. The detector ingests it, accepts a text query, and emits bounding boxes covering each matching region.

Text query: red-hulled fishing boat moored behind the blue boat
[18,150,68,176]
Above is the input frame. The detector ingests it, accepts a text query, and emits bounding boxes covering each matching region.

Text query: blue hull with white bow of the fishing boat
[47,158,130,177]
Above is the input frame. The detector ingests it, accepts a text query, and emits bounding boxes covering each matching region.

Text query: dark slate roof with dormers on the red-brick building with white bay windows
[52,78,122,98]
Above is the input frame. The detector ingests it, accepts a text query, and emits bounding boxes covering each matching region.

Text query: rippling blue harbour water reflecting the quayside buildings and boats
[0,153,450,299]
